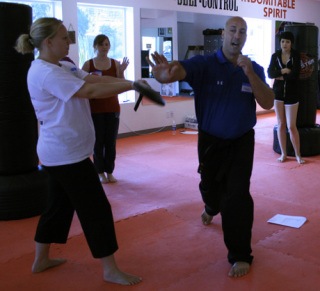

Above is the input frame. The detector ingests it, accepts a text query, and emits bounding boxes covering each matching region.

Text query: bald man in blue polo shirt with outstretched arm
[148,17,274,277]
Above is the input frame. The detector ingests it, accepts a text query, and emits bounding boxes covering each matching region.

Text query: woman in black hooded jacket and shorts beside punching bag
[268,31,305,164]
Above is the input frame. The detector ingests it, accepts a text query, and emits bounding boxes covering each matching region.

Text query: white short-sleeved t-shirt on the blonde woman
[27,59,95,166]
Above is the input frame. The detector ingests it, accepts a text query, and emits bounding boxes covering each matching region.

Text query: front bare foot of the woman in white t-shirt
[101,255,142,285]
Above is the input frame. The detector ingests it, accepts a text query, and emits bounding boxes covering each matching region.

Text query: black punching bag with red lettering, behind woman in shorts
[273,24,320,156]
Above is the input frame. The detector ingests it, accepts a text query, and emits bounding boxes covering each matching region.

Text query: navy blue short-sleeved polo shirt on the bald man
[180,49,266,139]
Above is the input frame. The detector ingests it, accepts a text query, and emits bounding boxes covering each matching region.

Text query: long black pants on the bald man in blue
[198,130,254,264]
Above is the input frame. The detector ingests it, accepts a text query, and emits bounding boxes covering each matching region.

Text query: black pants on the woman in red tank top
[92,112,120,174]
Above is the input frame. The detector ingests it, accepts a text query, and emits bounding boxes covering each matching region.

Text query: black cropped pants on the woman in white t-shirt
[35,158,118,258]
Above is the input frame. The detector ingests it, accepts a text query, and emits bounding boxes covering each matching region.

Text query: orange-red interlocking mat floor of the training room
[0,111,320,291]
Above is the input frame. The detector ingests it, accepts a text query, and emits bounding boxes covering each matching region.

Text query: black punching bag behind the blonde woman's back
[0,2,47,220]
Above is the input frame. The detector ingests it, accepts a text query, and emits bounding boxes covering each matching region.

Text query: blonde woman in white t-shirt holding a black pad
[16,18,141,285]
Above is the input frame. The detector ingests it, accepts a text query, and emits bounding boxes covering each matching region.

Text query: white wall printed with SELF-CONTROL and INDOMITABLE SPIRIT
[62,0,320,133]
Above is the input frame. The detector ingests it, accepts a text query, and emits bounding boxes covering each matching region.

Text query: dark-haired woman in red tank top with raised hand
[82,34,129,183]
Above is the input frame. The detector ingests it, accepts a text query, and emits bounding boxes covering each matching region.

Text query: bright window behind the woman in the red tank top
[77,3,135,103]
